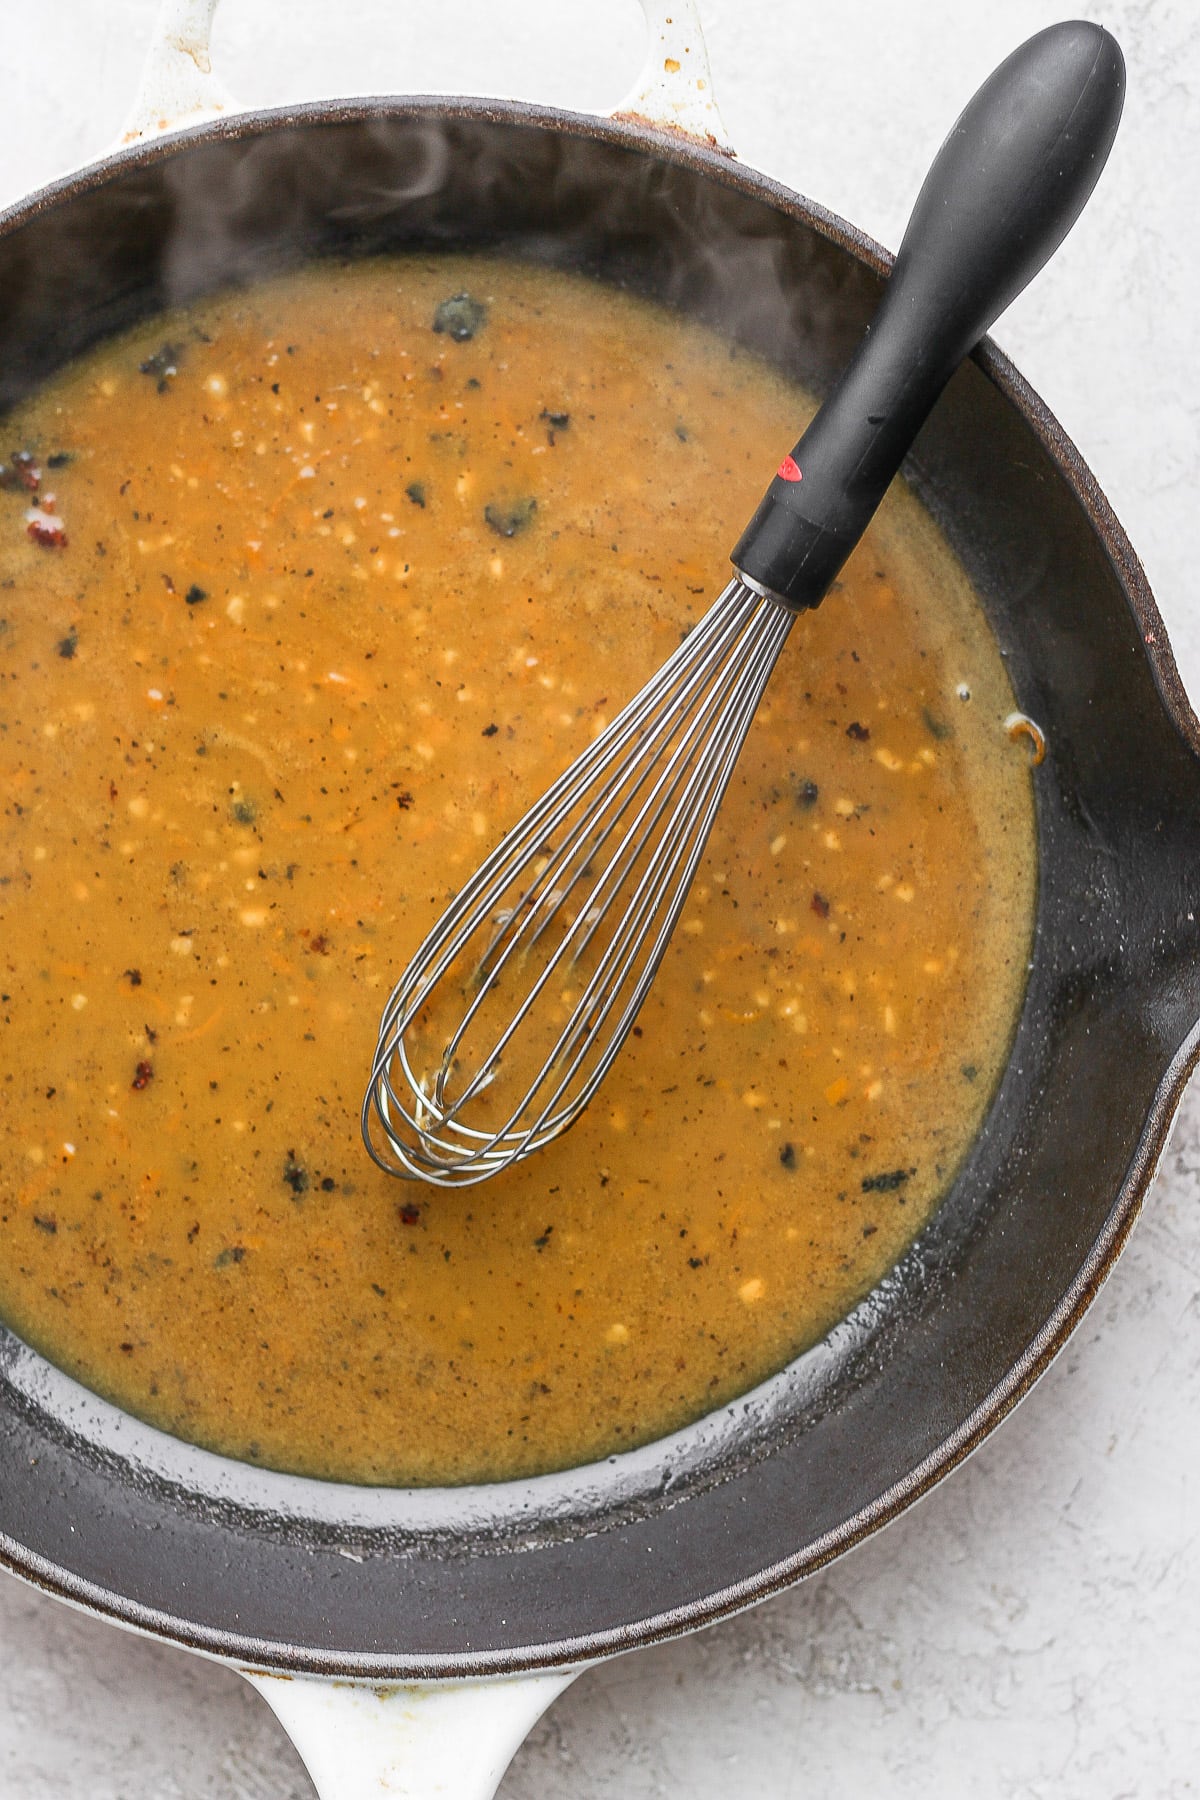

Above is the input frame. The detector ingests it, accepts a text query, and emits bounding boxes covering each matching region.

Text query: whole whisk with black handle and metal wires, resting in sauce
[362,22,1124,1186]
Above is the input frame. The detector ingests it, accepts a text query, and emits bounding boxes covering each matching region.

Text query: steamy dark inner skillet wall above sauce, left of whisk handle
[0,103,892,419]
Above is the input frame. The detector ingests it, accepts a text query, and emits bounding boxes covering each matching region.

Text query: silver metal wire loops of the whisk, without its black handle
[362,578,795,1186]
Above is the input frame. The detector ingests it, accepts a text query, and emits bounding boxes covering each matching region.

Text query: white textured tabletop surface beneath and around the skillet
[0,0,1200,1800]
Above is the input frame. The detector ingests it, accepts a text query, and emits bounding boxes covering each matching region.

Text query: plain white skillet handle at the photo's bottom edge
[241,1669,578,1800]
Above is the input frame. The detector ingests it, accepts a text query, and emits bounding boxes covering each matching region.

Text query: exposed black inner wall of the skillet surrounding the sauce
[0,101,1200,1678]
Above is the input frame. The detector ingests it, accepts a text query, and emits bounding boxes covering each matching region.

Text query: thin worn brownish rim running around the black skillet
[0,95,1200,1681]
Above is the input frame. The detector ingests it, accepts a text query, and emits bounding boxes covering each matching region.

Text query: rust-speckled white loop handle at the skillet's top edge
[113,0,732,155]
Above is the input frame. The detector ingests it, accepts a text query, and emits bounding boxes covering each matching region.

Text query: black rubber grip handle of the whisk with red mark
[732,20,1124,610]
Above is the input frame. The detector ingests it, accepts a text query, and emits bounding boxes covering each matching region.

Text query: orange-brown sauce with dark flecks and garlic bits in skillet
[0,257,1034,1483]
